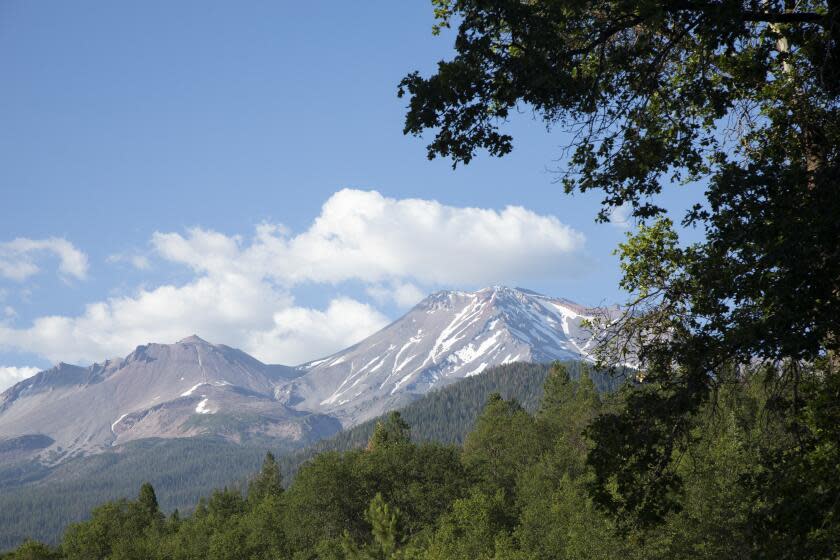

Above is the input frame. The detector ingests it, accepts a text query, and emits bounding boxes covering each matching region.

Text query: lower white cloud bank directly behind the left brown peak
[0,270,387,364]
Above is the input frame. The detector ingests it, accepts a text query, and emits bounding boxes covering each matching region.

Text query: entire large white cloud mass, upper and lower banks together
[0,190,588,364]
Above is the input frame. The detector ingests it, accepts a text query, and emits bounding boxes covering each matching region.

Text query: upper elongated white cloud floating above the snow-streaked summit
[153,189,587,286]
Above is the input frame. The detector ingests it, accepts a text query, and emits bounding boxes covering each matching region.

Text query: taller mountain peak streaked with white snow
[278,286,617,427]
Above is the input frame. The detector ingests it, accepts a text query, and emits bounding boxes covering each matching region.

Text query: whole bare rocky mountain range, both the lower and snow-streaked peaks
[0,287,612,465]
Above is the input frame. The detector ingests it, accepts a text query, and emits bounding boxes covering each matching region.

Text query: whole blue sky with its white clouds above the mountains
[0,0,704,383]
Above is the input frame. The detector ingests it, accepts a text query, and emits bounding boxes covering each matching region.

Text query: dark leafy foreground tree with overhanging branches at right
[399,0,840,544]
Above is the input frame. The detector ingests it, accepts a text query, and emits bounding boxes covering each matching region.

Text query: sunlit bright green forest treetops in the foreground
[5,364,837,560]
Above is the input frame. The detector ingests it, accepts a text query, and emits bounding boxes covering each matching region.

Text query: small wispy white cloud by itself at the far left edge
[0,237,88,282]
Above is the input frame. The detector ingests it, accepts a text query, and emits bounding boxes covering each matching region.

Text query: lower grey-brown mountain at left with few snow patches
[0,336,339,462]
